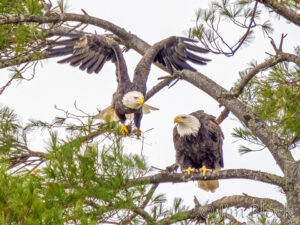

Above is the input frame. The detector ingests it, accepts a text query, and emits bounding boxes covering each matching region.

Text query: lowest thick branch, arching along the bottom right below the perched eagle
[158,195,286,224]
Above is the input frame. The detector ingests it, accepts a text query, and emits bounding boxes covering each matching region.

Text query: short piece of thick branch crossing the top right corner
[259,0,300,26]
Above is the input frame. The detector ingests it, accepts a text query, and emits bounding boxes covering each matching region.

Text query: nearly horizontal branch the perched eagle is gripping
[130,169,286,188]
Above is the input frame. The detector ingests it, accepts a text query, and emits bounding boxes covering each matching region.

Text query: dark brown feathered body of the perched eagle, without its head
[173,110,224,170]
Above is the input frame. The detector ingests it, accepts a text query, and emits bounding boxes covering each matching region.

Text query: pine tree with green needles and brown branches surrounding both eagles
[0,0,300,225]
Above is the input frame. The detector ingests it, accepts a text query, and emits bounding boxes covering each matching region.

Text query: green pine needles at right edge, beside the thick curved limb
[233,62,300,153]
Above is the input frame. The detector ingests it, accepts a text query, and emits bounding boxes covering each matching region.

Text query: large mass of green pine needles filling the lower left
[0,107,192,224]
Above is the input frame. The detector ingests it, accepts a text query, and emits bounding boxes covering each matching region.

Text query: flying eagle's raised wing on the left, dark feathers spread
[45,33,129,80]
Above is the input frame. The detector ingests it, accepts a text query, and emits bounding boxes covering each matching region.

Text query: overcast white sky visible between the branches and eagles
[0,0,300,217]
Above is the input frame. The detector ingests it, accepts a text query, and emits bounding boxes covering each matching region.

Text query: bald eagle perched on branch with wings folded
[173,110,224,192]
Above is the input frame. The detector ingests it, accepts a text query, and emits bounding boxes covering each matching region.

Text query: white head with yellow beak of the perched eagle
[174,114,201,137]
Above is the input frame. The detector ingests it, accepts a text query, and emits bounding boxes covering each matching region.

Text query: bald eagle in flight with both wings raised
[46,33,210,136]
